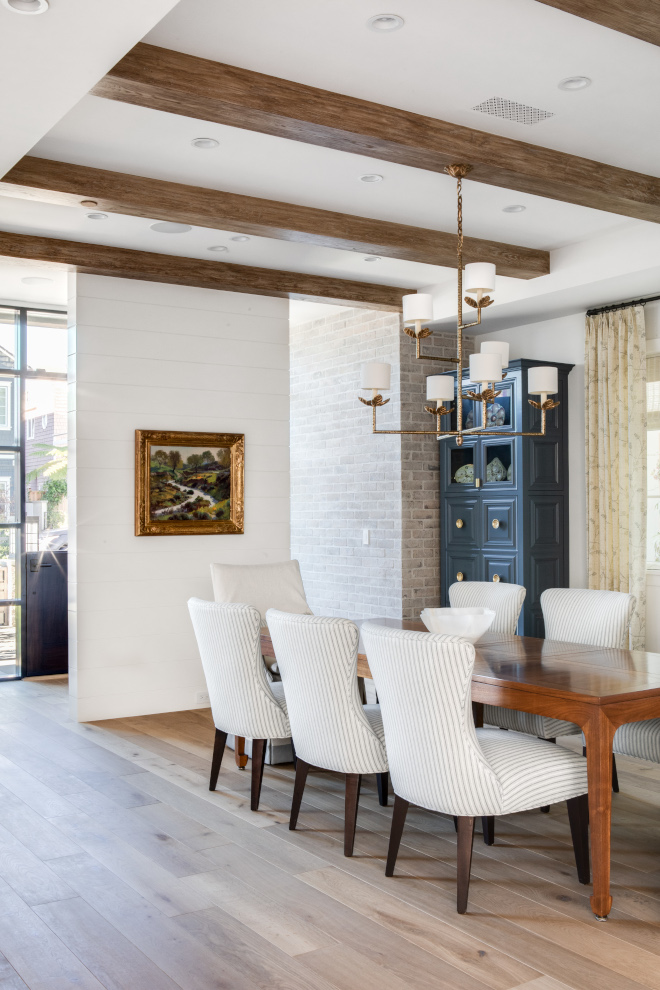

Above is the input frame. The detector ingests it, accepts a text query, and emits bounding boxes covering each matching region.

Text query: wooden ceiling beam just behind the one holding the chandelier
[0,158,550,278]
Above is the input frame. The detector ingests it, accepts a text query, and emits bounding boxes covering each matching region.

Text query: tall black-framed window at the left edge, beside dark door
[0,306,68,680]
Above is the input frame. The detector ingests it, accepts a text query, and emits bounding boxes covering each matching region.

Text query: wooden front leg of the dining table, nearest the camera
[583,708,615,921]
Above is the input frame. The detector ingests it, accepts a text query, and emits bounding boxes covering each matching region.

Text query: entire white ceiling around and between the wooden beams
[0,0,660,302]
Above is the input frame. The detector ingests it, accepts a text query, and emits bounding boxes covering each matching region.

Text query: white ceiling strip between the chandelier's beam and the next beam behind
[32,96,634,254]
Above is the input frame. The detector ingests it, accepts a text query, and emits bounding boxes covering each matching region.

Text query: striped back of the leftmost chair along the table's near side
[188,598,291,739]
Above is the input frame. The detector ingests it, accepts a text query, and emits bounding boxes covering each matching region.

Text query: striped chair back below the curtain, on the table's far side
[541,588,636,649]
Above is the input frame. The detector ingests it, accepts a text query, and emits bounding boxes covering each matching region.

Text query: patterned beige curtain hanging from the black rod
[584,306,646,650]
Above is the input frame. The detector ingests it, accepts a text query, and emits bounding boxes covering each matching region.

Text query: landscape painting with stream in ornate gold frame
[135,430,245,536]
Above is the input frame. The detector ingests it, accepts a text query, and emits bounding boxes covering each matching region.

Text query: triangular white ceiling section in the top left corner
[0,0,178,175]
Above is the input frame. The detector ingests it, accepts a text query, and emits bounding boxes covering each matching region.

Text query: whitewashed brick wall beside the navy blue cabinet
[290,308,470,618]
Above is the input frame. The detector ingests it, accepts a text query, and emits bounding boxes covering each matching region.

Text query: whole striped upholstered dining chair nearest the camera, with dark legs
[362,622,589,914]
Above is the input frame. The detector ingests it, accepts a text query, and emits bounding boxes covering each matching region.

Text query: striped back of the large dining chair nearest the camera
[361,622,502,815]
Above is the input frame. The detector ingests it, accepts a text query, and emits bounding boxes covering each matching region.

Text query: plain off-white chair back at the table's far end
[211,560,312,626]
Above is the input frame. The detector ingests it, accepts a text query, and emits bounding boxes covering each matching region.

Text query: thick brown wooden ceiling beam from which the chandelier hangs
[92,43,660,223]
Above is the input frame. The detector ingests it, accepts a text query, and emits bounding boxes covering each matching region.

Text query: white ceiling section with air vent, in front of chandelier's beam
[144,0,660,175]
